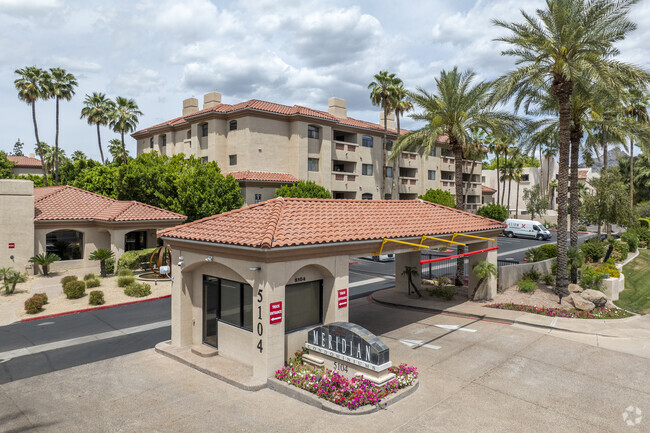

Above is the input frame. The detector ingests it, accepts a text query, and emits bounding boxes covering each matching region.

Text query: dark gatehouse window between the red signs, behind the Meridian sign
[284,281,323,332]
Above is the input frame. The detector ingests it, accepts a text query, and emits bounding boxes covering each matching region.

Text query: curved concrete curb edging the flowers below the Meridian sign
[266,377,420,415]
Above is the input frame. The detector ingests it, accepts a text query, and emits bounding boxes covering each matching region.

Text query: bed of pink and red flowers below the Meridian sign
[275,352,418,409]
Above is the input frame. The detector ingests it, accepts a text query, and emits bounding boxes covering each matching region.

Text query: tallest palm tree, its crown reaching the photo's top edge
[493,0,650,294]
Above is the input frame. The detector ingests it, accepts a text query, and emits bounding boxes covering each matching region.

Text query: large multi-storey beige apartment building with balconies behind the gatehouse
[132,92,482,211]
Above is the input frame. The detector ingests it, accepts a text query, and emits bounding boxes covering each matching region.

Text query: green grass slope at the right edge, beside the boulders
[614,249,650,314]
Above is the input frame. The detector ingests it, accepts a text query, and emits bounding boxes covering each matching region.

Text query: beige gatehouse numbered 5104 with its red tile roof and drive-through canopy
[158,198,505,380]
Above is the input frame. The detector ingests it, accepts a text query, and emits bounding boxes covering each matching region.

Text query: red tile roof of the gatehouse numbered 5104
[158,198,505,249]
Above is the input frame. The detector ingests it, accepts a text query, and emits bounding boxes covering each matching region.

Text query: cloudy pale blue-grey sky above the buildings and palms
[0,0,650,159]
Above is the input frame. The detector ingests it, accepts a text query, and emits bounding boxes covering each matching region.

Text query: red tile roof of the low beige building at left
[34,185,187,223]
